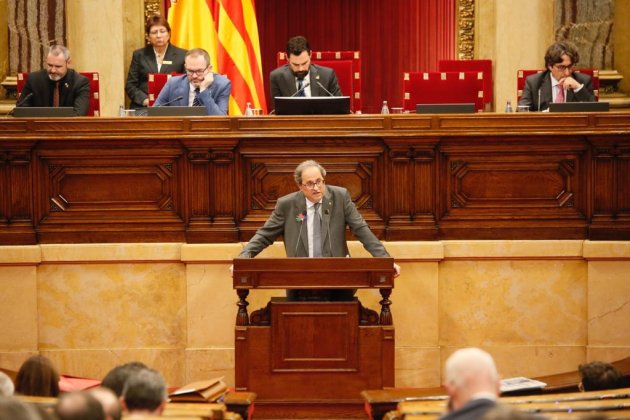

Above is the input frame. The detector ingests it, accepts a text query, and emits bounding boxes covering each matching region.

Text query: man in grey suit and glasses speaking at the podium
[238,160,400,300]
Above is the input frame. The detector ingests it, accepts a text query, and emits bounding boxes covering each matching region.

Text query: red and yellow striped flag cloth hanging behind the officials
[168,0,267,115]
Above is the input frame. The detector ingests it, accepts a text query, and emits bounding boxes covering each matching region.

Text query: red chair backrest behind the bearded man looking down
[276,51,362,112]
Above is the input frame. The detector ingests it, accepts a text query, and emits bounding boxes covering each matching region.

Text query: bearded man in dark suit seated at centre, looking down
[271,36,341,98]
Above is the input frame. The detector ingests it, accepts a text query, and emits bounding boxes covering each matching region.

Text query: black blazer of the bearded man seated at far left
[18,69,90,117]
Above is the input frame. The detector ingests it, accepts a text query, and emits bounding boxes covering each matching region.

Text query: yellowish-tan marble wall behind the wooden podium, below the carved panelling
[0,241,630,387]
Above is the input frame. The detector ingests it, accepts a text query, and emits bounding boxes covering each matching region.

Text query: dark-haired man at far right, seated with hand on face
[518,42,595,111]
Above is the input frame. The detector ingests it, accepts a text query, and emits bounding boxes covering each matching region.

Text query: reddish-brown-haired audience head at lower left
[15,355,59,397]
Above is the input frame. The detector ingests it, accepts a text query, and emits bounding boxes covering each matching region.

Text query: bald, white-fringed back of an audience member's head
[444,348,500,410]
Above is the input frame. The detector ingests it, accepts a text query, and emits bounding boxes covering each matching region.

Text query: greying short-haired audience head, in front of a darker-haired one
[121,368,167,416]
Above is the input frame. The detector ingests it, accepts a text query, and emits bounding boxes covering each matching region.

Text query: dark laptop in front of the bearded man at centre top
[273,96,350,115]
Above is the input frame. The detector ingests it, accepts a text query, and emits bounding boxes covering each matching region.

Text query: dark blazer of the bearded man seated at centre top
[270,64,341,99]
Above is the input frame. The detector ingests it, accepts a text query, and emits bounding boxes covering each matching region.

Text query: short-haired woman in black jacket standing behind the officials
[125,15,186,108]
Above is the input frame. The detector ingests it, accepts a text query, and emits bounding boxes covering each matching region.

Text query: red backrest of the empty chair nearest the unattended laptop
[403,71,484,112]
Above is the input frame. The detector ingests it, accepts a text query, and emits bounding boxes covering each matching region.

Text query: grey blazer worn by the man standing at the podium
[239,185,389,258]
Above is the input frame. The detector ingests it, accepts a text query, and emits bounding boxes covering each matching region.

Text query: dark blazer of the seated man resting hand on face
[518,70,595,111]
